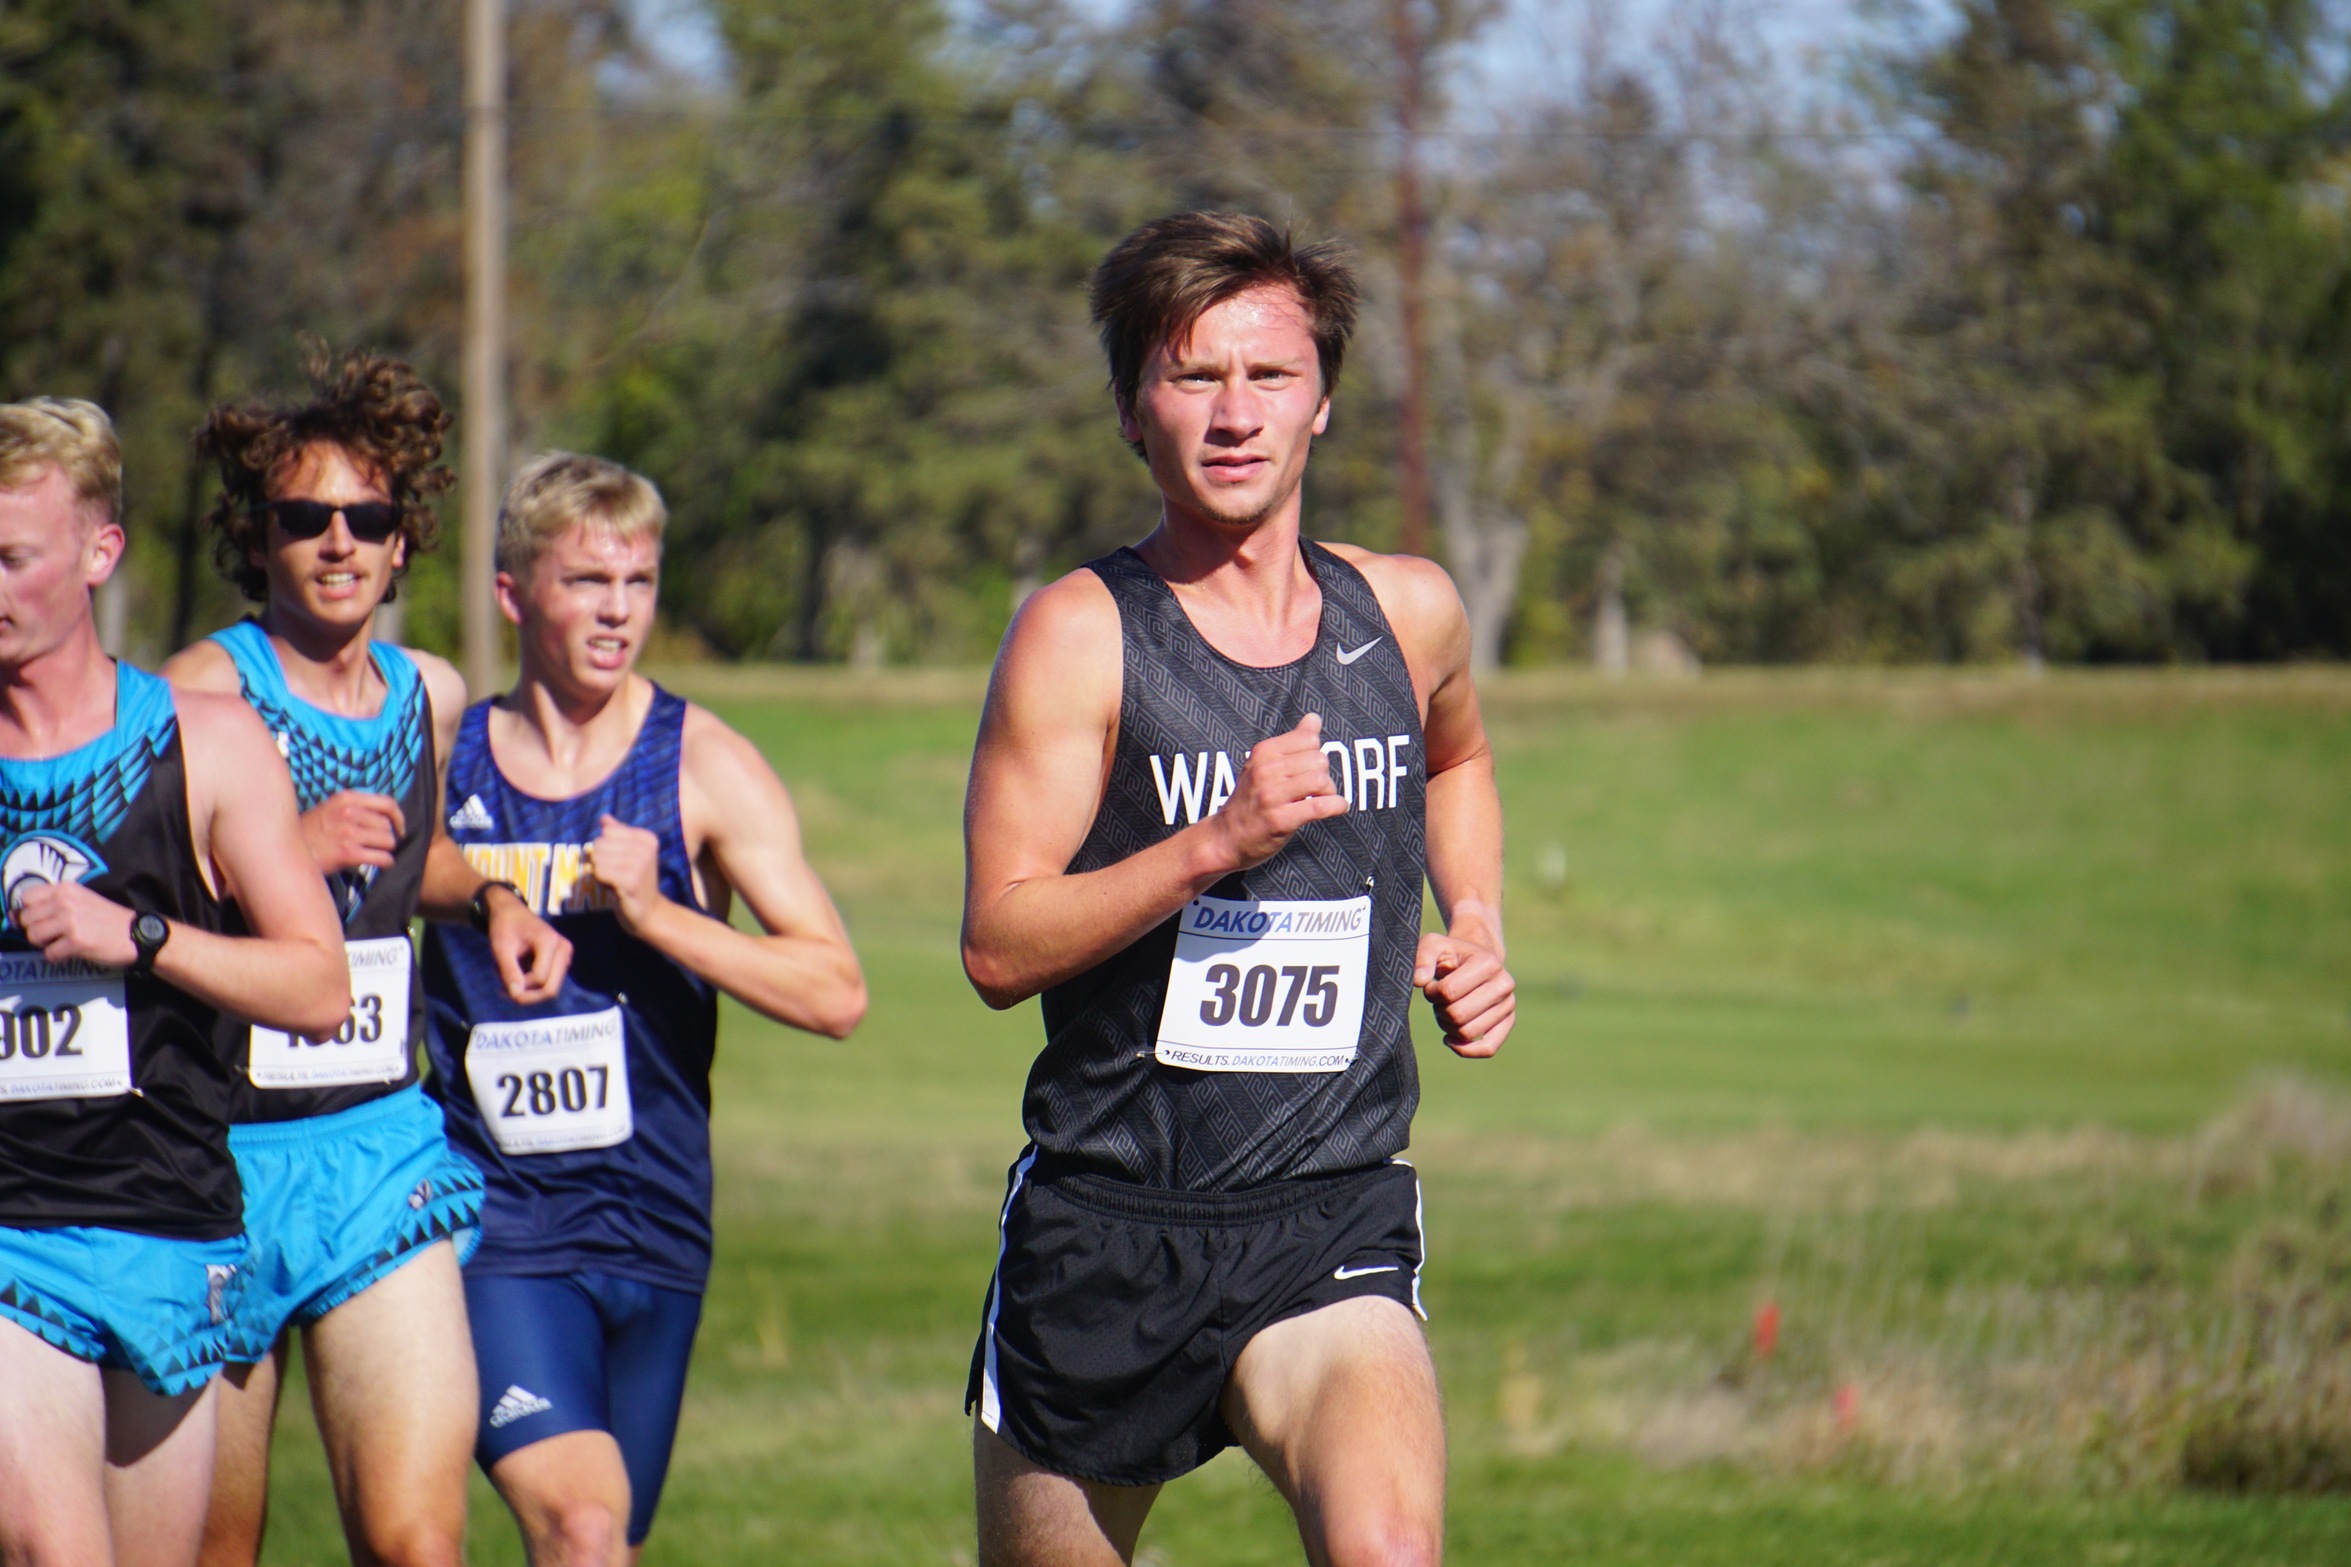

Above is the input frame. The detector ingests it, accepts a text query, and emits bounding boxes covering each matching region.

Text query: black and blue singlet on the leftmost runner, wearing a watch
[0,663,245,1240]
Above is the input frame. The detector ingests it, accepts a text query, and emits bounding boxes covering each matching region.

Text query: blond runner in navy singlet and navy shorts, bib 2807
[426,453,865,1562]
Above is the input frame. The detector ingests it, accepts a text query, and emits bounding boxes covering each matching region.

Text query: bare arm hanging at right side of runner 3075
[1338,545,1519,1057]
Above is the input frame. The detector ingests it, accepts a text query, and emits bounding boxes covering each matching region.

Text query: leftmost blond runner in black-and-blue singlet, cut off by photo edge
[0,399,350,1565]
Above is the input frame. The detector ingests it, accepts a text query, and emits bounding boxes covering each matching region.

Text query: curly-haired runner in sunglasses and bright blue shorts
[165,355,569,1565]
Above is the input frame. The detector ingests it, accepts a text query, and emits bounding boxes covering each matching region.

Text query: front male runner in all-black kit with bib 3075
[964,214,1514,1567]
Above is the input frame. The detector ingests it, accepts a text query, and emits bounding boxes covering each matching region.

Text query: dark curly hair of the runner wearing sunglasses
[195,345,456,604]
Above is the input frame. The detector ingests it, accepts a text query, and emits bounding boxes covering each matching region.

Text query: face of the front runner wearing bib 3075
[1121,287,1331,529]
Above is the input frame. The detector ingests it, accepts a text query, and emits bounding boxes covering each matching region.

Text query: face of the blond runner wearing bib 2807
[498,524,661,691]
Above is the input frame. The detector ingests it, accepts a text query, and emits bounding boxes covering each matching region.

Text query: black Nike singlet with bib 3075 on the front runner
[1023,543,1427,1191]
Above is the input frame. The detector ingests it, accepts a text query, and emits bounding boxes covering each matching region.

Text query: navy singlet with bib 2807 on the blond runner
[426,686,717,1290]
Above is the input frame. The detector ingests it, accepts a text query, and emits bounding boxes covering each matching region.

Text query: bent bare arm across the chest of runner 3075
[964,571,1347,1008]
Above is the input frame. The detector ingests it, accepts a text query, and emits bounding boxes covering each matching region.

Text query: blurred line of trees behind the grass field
[0,0,2351,665]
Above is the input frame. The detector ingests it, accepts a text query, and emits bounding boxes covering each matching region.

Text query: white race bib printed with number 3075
[1154,897,1371,1071]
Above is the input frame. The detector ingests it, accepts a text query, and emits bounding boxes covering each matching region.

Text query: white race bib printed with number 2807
[465,1008,637,1154]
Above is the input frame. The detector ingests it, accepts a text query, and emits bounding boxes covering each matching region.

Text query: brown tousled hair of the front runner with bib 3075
[1086,211,1361,453]
